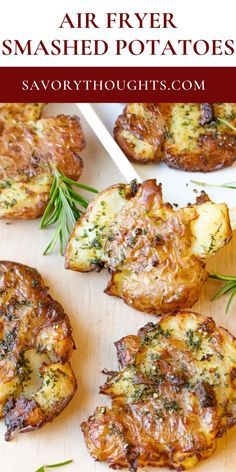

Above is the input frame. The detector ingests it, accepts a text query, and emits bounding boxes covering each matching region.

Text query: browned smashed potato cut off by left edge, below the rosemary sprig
[0,261,76,440]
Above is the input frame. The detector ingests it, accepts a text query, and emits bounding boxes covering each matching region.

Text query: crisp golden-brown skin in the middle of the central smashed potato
[106,180,208,315]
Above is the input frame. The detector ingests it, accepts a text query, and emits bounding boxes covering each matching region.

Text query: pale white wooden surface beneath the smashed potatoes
[0,105,236,472]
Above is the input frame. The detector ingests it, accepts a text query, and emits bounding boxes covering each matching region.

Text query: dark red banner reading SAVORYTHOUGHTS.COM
[0,67,236,102]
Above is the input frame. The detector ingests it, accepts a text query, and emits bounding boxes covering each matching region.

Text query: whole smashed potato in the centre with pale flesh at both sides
[66,180,232,314]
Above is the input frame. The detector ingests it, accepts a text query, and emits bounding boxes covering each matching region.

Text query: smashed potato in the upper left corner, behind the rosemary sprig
[0,103,85,219]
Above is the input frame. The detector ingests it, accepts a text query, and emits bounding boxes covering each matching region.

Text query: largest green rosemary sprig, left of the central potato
[40,169,98,255]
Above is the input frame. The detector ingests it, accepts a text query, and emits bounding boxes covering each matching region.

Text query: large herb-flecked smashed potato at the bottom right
[81,311,236,472]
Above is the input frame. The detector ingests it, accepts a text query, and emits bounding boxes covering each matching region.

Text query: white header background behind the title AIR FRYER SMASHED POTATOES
[0,0,236,67]
